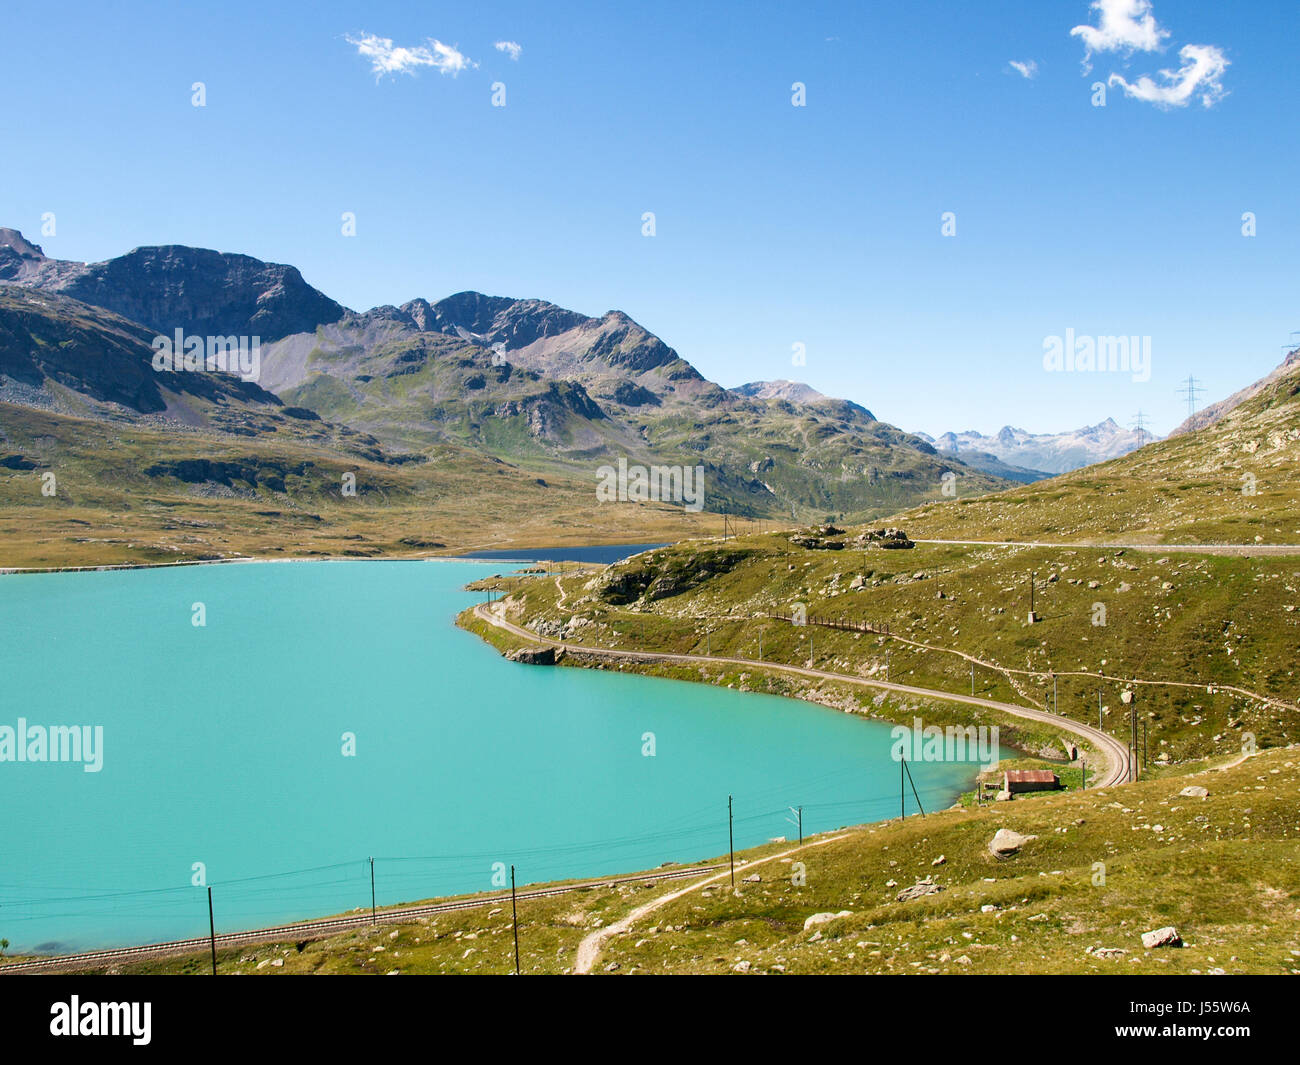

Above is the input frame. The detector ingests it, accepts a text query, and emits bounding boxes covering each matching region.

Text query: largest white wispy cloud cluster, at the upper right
[1070,0,1229,108]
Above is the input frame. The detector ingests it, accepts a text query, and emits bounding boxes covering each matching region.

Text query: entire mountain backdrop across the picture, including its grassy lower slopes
[0,229,1300,560]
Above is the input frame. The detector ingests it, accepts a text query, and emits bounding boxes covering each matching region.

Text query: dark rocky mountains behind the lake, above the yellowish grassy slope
[0,229,1005,519]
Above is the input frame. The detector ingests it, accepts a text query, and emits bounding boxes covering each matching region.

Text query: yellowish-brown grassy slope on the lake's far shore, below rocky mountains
[0,403,722,568]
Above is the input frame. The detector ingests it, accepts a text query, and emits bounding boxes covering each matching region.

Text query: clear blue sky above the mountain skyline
[0,0,1300,433]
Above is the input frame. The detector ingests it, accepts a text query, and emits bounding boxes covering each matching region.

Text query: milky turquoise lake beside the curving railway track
[0,562,975,952]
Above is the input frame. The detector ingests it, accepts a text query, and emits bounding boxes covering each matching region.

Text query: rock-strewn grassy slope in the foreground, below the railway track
[43,748,1300,975]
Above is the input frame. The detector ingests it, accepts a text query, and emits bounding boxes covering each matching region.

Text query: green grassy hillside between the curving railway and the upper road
[467,529,1300,762]
